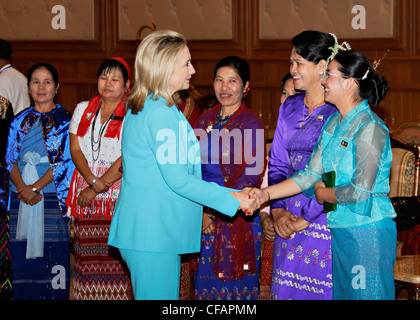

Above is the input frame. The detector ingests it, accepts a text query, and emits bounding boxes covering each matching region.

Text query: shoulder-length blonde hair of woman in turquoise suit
[126,30,187,114]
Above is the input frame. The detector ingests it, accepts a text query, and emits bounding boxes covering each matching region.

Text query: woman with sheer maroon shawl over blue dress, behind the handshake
[194,56,266,300]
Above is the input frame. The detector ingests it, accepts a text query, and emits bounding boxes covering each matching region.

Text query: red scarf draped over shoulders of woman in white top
[77,95,127,139]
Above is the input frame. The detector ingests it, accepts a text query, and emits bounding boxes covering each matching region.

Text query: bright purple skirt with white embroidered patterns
[271,215,333,300]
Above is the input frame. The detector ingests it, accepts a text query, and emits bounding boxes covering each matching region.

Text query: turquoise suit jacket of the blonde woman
[108,96,239,254]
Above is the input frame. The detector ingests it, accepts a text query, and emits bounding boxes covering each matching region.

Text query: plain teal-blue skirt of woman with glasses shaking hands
[331,219,397,300]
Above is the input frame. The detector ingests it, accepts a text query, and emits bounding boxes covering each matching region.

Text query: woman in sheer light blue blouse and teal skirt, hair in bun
[251,50,397,300]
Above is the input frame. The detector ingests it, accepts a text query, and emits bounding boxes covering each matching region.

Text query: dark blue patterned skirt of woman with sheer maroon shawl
[194,216,262,300]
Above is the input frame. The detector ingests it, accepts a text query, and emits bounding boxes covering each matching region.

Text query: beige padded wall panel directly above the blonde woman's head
[118,0,233,41]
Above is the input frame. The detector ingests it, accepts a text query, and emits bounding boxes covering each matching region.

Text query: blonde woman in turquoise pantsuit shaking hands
[108,30,260,300]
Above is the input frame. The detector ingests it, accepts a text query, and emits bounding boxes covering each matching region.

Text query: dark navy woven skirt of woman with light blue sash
[9,192,70,300]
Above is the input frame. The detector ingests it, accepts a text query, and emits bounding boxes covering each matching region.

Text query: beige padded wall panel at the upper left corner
[0,0,95,41]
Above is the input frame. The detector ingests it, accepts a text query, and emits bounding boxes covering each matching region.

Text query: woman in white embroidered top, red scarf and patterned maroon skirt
[67,57,132,300]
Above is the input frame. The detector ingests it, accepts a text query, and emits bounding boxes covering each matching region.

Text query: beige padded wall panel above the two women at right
[259,0,395,40]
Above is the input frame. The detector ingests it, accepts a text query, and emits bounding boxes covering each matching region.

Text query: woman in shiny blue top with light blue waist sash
[0,63,74,300]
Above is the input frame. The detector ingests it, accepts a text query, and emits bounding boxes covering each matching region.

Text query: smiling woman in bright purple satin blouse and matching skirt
[268,31,346,300]
